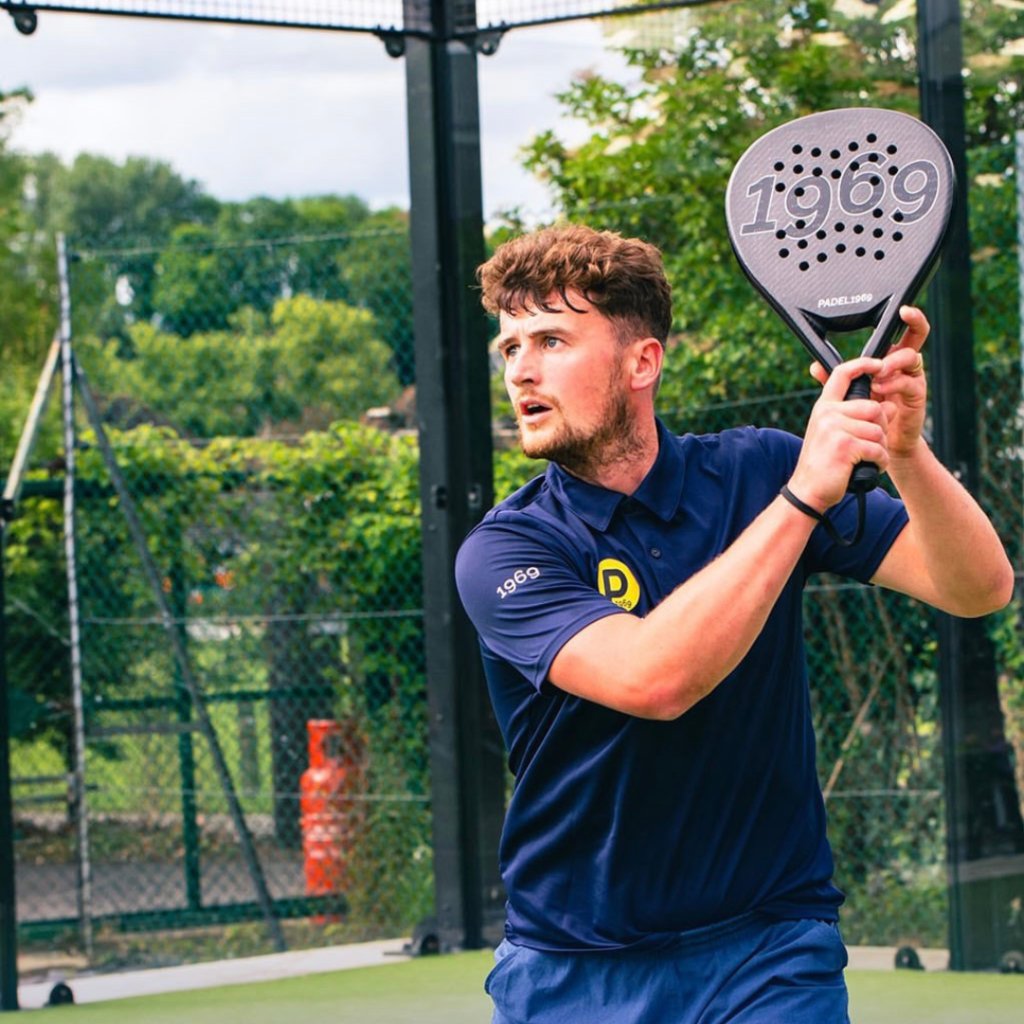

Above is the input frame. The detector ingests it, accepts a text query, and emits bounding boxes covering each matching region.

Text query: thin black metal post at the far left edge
[0,532,17,1010]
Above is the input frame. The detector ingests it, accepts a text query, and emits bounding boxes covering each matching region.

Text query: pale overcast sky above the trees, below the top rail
[0,11,628,215]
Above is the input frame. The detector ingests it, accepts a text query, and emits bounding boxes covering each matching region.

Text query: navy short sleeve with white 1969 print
[456,520,628,689]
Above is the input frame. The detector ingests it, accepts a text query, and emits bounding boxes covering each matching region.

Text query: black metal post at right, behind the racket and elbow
[918,0,1024,971]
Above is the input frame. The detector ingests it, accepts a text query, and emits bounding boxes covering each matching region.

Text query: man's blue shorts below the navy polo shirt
[485,914,850,1024]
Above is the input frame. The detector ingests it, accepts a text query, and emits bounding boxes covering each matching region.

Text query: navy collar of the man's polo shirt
[547,420,686,532]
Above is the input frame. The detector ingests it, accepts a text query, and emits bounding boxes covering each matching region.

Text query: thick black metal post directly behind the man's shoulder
[406,0,504,948]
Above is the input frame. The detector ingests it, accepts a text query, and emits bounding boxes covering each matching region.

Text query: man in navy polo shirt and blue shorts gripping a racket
[457,225,1013,1024]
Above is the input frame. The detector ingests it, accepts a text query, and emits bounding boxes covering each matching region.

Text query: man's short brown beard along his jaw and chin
[519,380,643,481]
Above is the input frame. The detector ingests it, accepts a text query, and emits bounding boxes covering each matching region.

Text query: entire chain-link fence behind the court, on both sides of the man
[5,41,1024,983]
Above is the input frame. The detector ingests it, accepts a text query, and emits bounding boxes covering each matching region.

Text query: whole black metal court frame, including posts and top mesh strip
[0,0,1019,995]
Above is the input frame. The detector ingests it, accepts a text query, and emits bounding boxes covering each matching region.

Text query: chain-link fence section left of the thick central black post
[7,232,433,965]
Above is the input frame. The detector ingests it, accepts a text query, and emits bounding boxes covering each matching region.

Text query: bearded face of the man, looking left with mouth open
[498,292,632,477]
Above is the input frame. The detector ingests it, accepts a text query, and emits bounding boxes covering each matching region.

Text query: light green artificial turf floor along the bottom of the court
[36,950,1024,1024]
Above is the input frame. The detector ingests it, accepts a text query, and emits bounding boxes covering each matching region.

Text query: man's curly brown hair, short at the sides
[476,224,672,345]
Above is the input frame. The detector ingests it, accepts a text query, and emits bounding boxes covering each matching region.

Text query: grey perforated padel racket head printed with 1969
[726,108,954,371]
